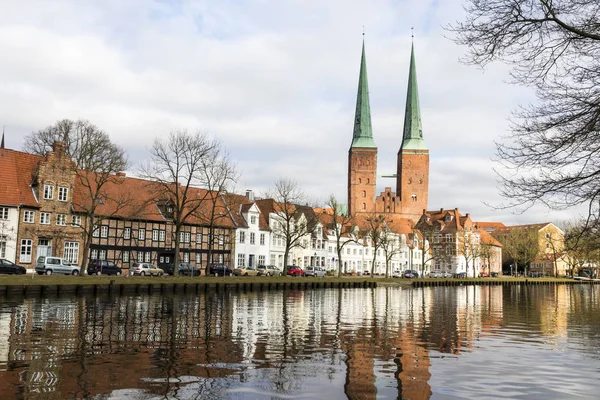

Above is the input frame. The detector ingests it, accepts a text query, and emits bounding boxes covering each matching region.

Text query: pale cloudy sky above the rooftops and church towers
[0,0,583,224]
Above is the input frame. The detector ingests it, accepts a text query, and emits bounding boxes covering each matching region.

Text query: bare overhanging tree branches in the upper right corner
[449,0,600,222]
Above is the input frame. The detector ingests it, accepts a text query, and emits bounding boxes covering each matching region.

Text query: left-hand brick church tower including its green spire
[348,40,377,215]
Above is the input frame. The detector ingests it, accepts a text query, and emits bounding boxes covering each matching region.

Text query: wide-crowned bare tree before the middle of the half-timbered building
[140,131,219,276]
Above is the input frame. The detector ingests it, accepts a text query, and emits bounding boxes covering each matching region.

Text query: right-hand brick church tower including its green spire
[396,46,429,221]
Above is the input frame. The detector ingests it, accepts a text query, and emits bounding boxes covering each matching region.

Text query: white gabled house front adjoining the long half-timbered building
[233,204,271,268]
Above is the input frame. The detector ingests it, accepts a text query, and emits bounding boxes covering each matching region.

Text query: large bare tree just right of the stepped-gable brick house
[25,119,133,270]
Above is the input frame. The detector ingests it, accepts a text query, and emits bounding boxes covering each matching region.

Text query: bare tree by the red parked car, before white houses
[268,178,317,267]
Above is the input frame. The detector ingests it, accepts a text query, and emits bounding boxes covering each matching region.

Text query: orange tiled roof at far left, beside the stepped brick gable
[0,149,44,207]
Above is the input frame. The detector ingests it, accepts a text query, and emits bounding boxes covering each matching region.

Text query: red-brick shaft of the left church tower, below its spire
[348,148,377,215]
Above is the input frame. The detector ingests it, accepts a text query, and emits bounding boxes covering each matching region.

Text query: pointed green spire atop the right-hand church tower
[402,45,427,150]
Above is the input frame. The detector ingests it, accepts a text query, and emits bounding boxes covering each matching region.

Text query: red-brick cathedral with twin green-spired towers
[348,41,429,222]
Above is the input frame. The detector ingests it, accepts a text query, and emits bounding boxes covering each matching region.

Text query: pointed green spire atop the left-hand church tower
[350,40,377,147]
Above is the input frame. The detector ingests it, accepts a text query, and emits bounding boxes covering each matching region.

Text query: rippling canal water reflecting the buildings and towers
[0,285,600,400]
